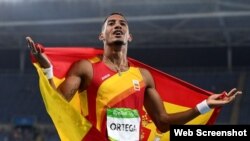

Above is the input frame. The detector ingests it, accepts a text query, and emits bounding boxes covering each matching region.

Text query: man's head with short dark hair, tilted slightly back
[99,13,132,45]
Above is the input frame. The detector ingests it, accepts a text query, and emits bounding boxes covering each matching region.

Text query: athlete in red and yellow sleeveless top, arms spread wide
[27,13,241,140]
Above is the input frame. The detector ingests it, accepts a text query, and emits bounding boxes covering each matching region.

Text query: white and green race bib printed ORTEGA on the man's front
[107,108,140,141]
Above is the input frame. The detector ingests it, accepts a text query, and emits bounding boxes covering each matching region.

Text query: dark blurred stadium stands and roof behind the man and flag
[0,0,250,141]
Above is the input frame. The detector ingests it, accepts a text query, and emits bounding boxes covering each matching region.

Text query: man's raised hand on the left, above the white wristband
[26,37,51,68]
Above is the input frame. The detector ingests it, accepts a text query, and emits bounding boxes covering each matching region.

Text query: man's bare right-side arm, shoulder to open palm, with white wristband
[141,69,241,132]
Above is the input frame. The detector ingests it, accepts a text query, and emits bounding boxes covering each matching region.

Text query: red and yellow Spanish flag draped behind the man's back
[31,47,220,141]
